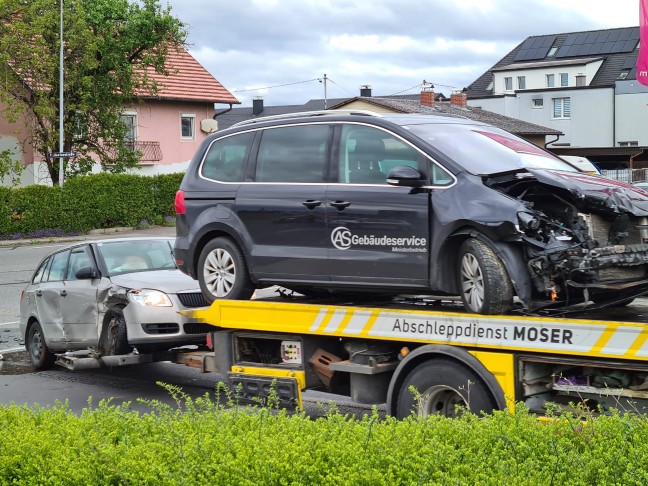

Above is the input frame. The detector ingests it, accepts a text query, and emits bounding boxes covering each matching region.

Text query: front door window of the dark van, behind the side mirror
[338,125,420,184]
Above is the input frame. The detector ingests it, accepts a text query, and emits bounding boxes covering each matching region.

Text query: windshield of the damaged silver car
[97,240,176,276]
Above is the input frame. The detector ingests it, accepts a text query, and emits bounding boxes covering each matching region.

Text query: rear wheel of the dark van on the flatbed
[198,237,255,303]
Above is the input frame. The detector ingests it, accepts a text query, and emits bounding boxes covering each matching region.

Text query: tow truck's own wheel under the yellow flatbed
[396,358,498,419]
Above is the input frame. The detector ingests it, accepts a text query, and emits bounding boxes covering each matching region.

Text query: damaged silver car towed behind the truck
[20,238,209,369]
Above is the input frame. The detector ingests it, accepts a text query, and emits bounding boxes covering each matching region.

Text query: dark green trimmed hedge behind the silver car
[0,173,183,239]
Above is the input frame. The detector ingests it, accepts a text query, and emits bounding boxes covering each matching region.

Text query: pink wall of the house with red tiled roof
[124,101,214,165]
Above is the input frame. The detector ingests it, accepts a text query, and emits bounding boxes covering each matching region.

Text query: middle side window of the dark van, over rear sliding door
[256,125,331,182]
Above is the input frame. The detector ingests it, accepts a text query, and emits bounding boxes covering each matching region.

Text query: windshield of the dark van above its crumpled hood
[407,124,578,175]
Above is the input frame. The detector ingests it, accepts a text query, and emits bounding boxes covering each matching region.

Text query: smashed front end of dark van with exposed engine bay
[486,170,648,305]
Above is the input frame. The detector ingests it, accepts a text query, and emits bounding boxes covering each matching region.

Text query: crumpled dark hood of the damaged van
[527,169,648,216]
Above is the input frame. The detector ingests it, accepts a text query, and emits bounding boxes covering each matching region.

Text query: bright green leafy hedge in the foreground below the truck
[0,397,648,486]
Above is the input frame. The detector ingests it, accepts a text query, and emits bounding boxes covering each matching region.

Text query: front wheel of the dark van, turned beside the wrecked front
[458,238,513,314]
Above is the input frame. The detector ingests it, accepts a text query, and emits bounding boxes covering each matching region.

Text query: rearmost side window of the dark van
[200,133,254,182]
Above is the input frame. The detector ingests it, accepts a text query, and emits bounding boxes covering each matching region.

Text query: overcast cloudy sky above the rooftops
[160,0,639,106]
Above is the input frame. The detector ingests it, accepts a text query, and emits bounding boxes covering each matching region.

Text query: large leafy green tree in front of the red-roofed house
[0,0,186,182]
